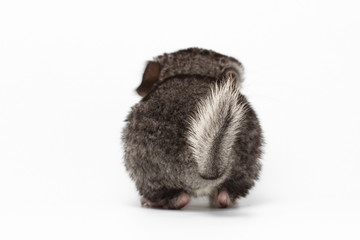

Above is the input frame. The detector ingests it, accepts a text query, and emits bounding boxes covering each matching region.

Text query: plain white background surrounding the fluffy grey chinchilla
[0,0,360,239]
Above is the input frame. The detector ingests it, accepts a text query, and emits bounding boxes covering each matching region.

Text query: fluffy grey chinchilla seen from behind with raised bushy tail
[122,48,263,209]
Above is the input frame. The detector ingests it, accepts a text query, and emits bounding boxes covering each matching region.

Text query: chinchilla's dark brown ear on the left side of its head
[136,61,160,97]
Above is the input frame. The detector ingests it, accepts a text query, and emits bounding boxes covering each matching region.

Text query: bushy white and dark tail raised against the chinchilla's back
[187,79,247,179]
